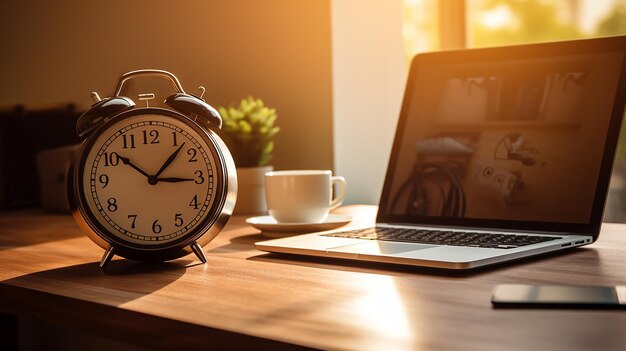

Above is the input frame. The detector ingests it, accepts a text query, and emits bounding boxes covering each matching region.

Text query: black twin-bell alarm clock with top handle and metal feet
[68,70,237,268]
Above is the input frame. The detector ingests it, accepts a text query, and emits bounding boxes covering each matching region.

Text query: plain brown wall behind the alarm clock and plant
[0,0,333,169]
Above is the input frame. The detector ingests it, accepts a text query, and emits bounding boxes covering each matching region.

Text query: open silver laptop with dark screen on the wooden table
[256,37,626,269]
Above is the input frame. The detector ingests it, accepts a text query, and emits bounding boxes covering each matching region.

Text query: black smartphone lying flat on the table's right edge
[491,284,626,308]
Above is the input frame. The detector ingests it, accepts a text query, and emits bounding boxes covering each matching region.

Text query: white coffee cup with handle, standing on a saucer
[265,170,346,223]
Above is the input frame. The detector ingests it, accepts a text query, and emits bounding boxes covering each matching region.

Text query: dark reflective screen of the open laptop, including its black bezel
[378,38,626,232]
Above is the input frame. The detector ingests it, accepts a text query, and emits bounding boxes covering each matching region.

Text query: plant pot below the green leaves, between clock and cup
[233,166,274,215]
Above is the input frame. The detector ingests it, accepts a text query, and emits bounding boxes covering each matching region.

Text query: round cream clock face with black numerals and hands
[81,114,222,246]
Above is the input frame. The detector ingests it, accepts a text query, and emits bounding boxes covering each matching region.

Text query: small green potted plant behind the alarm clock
[219,96,280,214]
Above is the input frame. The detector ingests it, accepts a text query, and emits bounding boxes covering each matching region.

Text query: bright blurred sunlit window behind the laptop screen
[402,0,626,222]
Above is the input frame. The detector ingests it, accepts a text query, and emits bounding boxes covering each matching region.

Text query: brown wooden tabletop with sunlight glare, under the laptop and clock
[0,206,626,350]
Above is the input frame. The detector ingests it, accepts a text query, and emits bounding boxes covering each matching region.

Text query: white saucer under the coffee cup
[246,214,352,233]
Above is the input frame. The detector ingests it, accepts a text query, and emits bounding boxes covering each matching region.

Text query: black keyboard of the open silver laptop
[321,227,560,249]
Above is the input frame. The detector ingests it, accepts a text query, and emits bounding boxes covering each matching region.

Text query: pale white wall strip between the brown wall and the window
[331,0,407,204]
